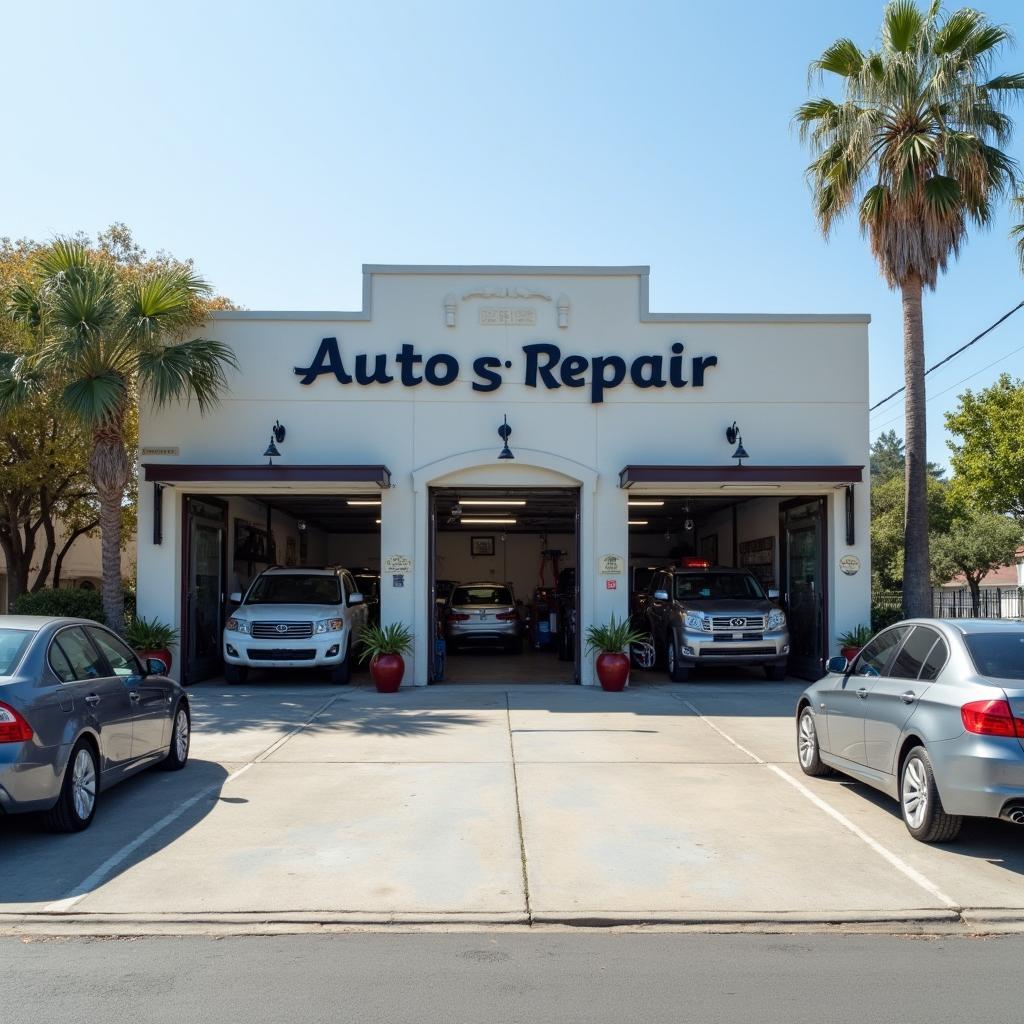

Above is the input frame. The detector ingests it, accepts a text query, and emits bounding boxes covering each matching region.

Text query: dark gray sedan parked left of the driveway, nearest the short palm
[0,615,191,831]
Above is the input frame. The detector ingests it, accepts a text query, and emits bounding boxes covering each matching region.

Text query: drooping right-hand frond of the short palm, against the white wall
[138,338,239,413]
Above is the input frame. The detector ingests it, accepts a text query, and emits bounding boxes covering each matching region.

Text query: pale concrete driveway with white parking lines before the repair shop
[0,678,1024,929]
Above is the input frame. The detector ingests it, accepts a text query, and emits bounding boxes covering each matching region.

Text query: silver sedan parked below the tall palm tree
[797,618,1024,843]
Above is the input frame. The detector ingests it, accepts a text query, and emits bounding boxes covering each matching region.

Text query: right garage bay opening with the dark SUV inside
[629,486,828,682]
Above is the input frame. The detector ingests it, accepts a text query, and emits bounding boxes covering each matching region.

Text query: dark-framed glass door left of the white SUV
[184,498,227,683]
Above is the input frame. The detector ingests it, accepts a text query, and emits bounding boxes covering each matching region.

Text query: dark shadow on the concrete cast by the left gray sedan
[0,760,228,909]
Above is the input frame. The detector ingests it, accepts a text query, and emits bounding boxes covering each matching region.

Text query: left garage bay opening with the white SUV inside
[180,488,381,683]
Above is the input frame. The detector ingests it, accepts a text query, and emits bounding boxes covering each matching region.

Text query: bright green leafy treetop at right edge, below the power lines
[946,374,1024,522]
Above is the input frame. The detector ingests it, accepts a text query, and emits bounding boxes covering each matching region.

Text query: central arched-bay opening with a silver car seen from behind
[430,487,580,683]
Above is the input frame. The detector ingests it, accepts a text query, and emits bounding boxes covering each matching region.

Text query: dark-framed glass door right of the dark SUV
[779,498,828,679]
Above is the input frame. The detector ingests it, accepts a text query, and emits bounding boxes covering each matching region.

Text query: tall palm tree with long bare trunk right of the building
[796,0,1024,615]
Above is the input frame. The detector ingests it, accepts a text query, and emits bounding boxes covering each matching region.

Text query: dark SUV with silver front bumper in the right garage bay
[637,568,790,683]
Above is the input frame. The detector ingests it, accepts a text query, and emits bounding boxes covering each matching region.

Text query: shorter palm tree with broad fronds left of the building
[0,239,238,631]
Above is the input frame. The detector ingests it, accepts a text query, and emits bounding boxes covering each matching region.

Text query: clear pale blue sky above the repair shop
[0,0,1024,462]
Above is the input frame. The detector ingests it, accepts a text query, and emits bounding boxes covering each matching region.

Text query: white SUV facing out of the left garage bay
[224,566,369,683]
